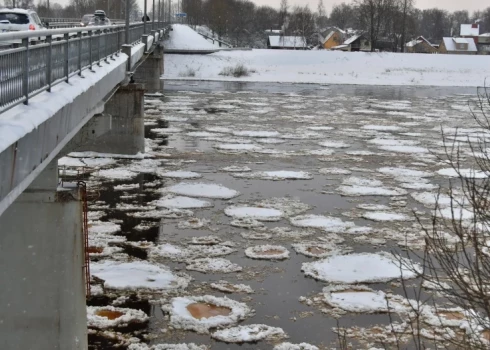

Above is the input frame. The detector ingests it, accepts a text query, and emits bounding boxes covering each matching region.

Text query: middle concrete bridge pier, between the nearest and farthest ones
[72,84,145,155]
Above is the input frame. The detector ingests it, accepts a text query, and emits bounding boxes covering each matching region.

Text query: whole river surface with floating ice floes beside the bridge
[74,82,490,350]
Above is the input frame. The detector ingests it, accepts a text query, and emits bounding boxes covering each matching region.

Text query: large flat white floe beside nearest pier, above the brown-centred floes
[90,261,190,290]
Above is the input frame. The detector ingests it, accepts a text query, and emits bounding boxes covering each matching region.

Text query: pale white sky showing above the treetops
[52,0,490,12]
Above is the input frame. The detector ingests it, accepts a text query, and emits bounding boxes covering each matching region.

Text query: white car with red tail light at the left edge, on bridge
[0,8,46,32]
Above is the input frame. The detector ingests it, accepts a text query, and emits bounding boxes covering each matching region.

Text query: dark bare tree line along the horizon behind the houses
[3,0,490,51]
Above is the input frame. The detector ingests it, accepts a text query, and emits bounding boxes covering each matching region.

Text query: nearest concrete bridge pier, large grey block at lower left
[0,160,87,350]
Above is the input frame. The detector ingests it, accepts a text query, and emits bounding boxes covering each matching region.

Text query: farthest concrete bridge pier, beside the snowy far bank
[133,44,164,93]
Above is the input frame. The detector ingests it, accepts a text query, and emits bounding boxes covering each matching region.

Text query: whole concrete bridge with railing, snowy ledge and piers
[0,23,166,350]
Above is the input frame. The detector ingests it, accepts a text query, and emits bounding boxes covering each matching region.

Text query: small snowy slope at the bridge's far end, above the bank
[164,24,219,50]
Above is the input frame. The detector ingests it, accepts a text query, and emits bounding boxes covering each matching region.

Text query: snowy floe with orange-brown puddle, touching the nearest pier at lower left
[87,306,150,329]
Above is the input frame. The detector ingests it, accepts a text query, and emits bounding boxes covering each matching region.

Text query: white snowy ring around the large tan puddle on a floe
[162,295,252,333]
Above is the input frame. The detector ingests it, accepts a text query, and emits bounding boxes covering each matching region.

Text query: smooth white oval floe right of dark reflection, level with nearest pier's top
[164,182,240,199]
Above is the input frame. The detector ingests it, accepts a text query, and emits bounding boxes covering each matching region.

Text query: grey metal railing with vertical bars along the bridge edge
[0,23,163,113]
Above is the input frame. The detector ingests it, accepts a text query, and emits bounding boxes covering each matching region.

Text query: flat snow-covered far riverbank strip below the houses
[163,49,490,86]
